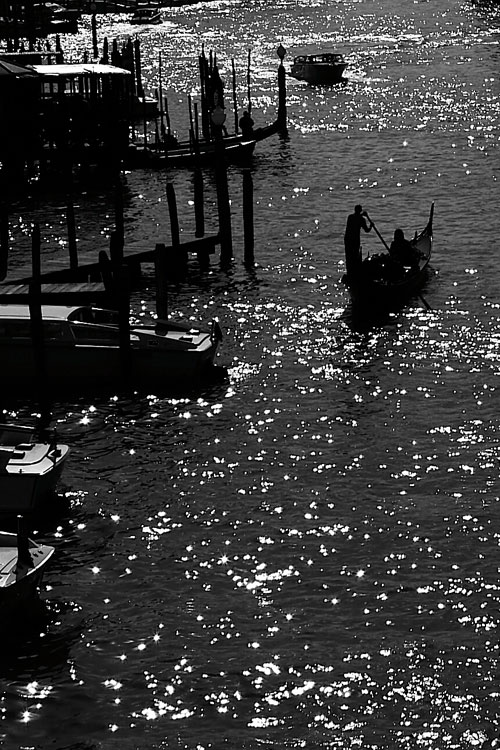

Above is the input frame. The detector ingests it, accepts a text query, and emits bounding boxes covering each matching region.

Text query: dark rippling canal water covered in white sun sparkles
[0,0,500,750]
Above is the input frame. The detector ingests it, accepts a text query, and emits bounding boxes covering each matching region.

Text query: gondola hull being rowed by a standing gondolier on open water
[342,203,434,312]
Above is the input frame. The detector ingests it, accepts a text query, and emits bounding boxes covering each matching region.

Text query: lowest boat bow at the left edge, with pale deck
[0,531,54,616]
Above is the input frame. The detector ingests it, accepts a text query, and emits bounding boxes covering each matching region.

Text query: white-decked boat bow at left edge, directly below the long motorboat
[0,424,69,514]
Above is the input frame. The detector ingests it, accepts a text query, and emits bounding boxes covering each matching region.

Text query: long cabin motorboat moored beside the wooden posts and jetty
[0,304,222,391]
